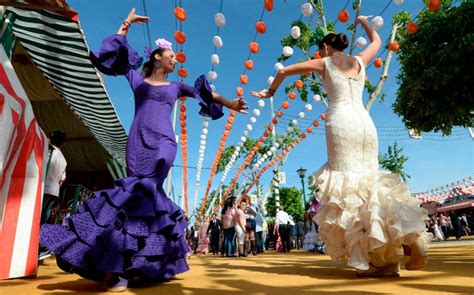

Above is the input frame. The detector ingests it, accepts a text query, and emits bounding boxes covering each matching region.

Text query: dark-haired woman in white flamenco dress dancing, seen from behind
[252,16,431,276]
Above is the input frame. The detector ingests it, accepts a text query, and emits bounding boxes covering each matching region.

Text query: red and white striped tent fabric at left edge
[0,45,48,279]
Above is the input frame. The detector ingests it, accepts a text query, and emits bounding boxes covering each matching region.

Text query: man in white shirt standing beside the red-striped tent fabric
[40,130,67,259]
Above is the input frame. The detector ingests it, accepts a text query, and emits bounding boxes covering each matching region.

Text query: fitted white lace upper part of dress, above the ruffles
[324,57,378,173]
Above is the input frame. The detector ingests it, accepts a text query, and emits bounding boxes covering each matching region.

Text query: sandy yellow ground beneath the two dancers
[0,240,474,295]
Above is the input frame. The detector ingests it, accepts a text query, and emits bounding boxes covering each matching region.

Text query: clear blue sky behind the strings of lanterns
[68,0,474,214]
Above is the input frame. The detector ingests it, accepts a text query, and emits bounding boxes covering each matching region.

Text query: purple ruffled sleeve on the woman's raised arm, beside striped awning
[89,34,143,76]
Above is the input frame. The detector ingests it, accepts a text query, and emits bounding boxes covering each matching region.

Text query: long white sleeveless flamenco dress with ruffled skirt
[314,57,431,270]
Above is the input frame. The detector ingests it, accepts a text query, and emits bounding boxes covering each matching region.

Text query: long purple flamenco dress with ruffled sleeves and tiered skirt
[40,35,223,281]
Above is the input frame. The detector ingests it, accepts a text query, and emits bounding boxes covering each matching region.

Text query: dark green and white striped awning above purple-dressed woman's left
[5,7,127,163]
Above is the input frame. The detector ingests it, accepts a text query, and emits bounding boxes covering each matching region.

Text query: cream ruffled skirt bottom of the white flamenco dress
[314,164,431,270]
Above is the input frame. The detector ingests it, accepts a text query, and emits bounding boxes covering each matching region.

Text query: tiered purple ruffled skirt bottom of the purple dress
[40,177,189,281]
